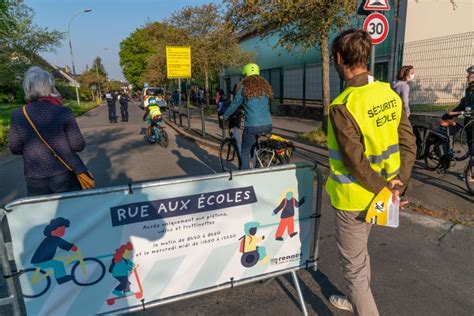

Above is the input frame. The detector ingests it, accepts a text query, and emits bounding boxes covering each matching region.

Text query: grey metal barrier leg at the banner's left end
[0,210,22,316]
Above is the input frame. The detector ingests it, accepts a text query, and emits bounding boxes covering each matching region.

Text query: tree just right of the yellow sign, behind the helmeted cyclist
[168,3,251,105]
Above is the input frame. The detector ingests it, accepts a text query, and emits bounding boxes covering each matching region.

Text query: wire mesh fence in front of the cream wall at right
[402,32,474,104]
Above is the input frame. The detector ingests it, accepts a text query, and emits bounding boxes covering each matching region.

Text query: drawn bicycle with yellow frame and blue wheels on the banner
[19,250,105,298]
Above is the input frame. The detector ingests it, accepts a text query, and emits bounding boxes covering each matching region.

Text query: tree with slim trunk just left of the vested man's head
[226,0,357,131]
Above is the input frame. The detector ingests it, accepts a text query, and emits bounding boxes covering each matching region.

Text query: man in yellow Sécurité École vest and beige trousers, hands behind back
[326,29,416,315]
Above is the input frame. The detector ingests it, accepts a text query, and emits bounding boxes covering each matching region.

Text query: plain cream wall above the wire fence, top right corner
[399,0,474,42]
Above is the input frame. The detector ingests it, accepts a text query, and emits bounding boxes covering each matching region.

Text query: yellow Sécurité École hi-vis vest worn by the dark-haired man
[326,81,402,211]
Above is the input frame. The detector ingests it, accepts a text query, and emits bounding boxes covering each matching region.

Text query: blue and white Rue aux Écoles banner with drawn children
[7,165,314,315]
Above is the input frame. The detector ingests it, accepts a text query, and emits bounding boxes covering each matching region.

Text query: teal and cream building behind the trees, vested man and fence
[220,0,474,117]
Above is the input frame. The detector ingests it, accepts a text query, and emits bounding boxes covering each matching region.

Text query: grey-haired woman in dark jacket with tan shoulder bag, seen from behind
[9,67,95,196]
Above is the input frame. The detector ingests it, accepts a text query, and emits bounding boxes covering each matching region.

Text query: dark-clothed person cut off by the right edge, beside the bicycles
[442,65,474,160]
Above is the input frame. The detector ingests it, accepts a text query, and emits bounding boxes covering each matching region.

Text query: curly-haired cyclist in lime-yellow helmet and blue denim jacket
[224,64,273,169]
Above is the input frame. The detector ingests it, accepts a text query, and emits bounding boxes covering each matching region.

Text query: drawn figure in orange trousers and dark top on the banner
[272,190,306,241]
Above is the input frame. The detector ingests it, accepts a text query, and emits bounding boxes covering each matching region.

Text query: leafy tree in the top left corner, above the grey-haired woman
[0,0,64,97]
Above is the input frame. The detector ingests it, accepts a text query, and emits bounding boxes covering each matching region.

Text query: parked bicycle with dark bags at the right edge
[414,110,474,193]
